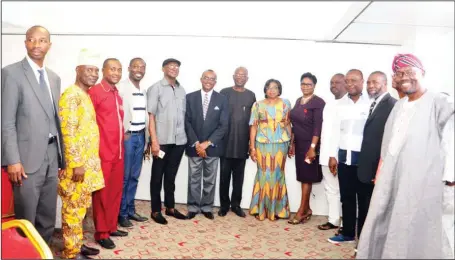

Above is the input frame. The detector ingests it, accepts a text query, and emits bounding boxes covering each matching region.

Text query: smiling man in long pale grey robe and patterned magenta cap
[357,54,455,259]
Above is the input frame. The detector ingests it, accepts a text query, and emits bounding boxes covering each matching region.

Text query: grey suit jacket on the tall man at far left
[1,58,65,174]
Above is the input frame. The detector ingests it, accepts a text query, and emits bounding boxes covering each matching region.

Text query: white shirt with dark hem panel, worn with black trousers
[329,95,371,165]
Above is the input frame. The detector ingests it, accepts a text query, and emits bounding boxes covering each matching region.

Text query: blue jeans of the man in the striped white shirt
[120,132,145,218]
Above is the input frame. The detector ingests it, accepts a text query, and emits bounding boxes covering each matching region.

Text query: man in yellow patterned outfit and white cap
[58,49,104,259]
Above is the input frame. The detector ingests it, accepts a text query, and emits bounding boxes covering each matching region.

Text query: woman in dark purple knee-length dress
[288,73,325,224]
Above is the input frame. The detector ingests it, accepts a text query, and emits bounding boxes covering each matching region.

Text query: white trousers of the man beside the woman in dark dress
[321,165,341,226]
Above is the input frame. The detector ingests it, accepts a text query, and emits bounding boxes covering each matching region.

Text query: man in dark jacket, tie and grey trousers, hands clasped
[185,70,229,219]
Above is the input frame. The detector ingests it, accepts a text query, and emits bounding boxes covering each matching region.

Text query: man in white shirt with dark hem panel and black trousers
[329,69,371,243]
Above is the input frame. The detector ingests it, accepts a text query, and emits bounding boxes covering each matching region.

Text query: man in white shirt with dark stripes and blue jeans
[118,58,148,227]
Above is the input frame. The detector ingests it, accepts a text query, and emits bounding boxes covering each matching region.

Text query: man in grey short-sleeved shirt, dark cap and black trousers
[147,58,187,225]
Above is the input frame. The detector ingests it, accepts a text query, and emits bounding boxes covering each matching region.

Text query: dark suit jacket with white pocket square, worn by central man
[185,90,229,157]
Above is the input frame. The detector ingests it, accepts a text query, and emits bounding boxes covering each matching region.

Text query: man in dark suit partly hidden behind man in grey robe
[357,71,397,237]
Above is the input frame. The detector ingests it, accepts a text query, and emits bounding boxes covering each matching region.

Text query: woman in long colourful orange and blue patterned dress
[250,79,291,221]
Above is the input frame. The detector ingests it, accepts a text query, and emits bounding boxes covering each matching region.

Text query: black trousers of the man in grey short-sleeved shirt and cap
[150,144,185,213]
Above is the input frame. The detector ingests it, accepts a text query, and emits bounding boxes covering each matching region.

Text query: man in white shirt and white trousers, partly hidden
[318,73,347,230]
